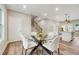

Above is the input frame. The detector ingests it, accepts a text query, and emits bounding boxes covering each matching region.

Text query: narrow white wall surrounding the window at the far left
[0,5,7,54]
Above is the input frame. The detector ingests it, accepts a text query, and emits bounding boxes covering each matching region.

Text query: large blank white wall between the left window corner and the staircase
[8,10,31,41]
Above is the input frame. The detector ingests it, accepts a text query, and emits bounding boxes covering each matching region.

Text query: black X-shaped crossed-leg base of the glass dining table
[29,35,53,55]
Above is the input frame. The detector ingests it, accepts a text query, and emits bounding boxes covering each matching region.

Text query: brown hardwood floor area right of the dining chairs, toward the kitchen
[60,41,79,55]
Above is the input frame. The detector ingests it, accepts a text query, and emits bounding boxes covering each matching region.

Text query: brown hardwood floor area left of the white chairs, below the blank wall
[3,41,23,55]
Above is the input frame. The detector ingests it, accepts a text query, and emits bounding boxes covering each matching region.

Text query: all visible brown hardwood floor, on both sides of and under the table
[3,41,79,55]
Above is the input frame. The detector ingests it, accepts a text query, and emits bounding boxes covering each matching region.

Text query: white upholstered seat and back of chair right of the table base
[44,36,59,51]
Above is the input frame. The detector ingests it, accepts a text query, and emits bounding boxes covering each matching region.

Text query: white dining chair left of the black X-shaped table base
[20,33,37,54]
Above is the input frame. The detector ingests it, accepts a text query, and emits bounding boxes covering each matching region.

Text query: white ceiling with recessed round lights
[6,4,79,21]
